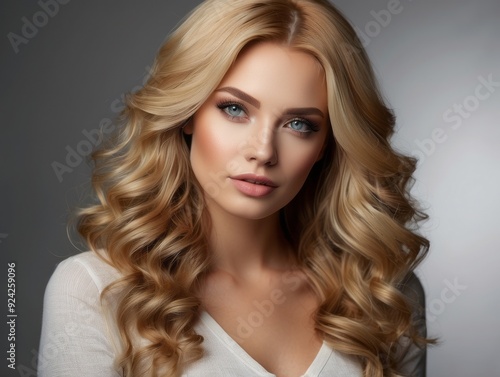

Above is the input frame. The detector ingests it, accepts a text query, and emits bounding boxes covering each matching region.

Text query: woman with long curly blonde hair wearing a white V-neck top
[39,0,428,377]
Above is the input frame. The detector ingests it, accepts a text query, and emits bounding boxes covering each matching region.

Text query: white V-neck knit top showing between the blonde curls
[38,252,368,377]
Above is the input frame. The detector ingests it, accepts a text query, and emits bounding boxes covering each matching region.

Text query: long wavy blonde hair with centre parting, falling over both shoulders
[78,0,429,376]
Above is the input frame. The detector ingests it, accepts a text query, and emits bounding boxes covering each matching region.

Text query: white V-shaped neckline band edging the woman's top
[200,311,333,377]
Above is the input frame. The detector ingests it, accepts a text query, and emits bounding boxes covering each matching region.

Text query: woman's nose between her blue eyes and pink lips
[244,127,278,166]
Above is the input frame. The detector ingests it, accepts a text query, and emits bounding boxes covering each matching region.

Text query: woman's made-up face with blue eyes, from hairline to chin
[186,43,329,219]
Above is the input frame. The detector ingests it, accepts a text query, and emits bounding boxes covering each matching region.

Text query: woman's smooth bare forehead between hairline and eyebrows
[219,42,327,109]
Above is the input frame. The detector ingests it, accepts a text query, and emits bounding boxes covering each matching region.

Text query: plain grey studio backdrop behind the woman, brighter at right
[0,0,500,377]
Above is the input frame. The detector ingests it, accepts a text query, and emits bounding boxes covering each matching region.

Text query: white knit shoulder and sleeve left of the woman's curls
[38,252,122,377]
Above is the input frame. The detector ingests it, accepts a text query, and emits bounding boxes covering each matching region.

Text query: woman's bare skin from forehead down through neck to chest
[185,42,329,377]
